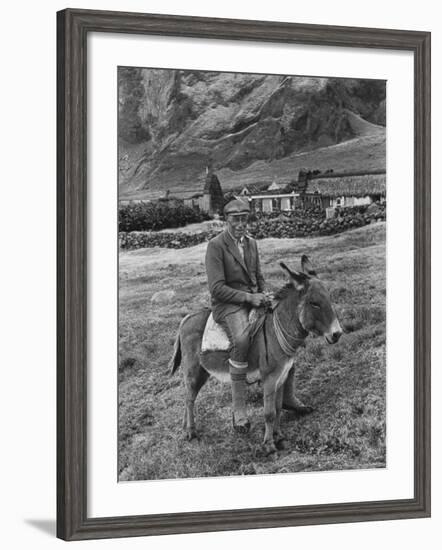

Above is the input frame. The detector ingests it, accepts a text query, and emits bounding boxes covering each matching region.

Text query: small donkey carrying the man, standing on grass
[169,255,342,454]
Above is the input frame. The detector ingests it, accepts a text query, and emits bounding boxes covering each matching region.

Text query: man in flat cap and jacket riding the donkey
[206,199,311,433]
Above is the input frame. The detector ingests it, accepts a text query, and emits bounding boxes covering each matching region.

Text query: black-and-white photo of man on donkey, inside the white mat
[118,66,388,481]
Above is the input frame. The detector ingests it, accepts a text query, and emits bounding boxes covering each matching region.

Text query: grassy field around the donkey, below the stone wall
[119,223,386,481]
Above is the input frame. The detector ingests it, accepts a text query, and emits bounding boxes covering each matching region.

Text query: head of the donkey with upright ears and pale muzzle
[280,255,342,344]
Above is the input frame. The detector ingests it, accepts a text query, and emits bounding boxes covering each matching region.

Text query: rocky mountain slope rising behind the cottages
[118,68,385,198]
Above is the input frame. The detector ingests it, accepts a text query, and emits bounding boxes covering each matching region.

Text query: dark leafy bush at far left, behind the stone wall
[118,201,209,232]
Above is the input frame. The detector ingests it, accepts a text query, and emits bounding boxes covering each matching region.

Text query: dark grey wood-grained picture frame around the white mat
[57,9,430,540]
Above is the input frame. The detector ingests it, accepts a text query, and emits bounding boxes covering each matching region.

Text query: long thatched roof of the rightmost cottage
[305,174,386,197]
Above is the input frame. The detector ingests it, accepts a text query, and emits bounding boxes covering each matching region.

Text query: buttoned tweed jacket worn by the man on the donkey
[206,229,264,322]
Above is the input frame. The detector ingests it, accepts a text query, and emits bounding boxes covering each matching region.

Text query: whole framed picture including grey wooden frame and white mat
[57,9,430,540]
